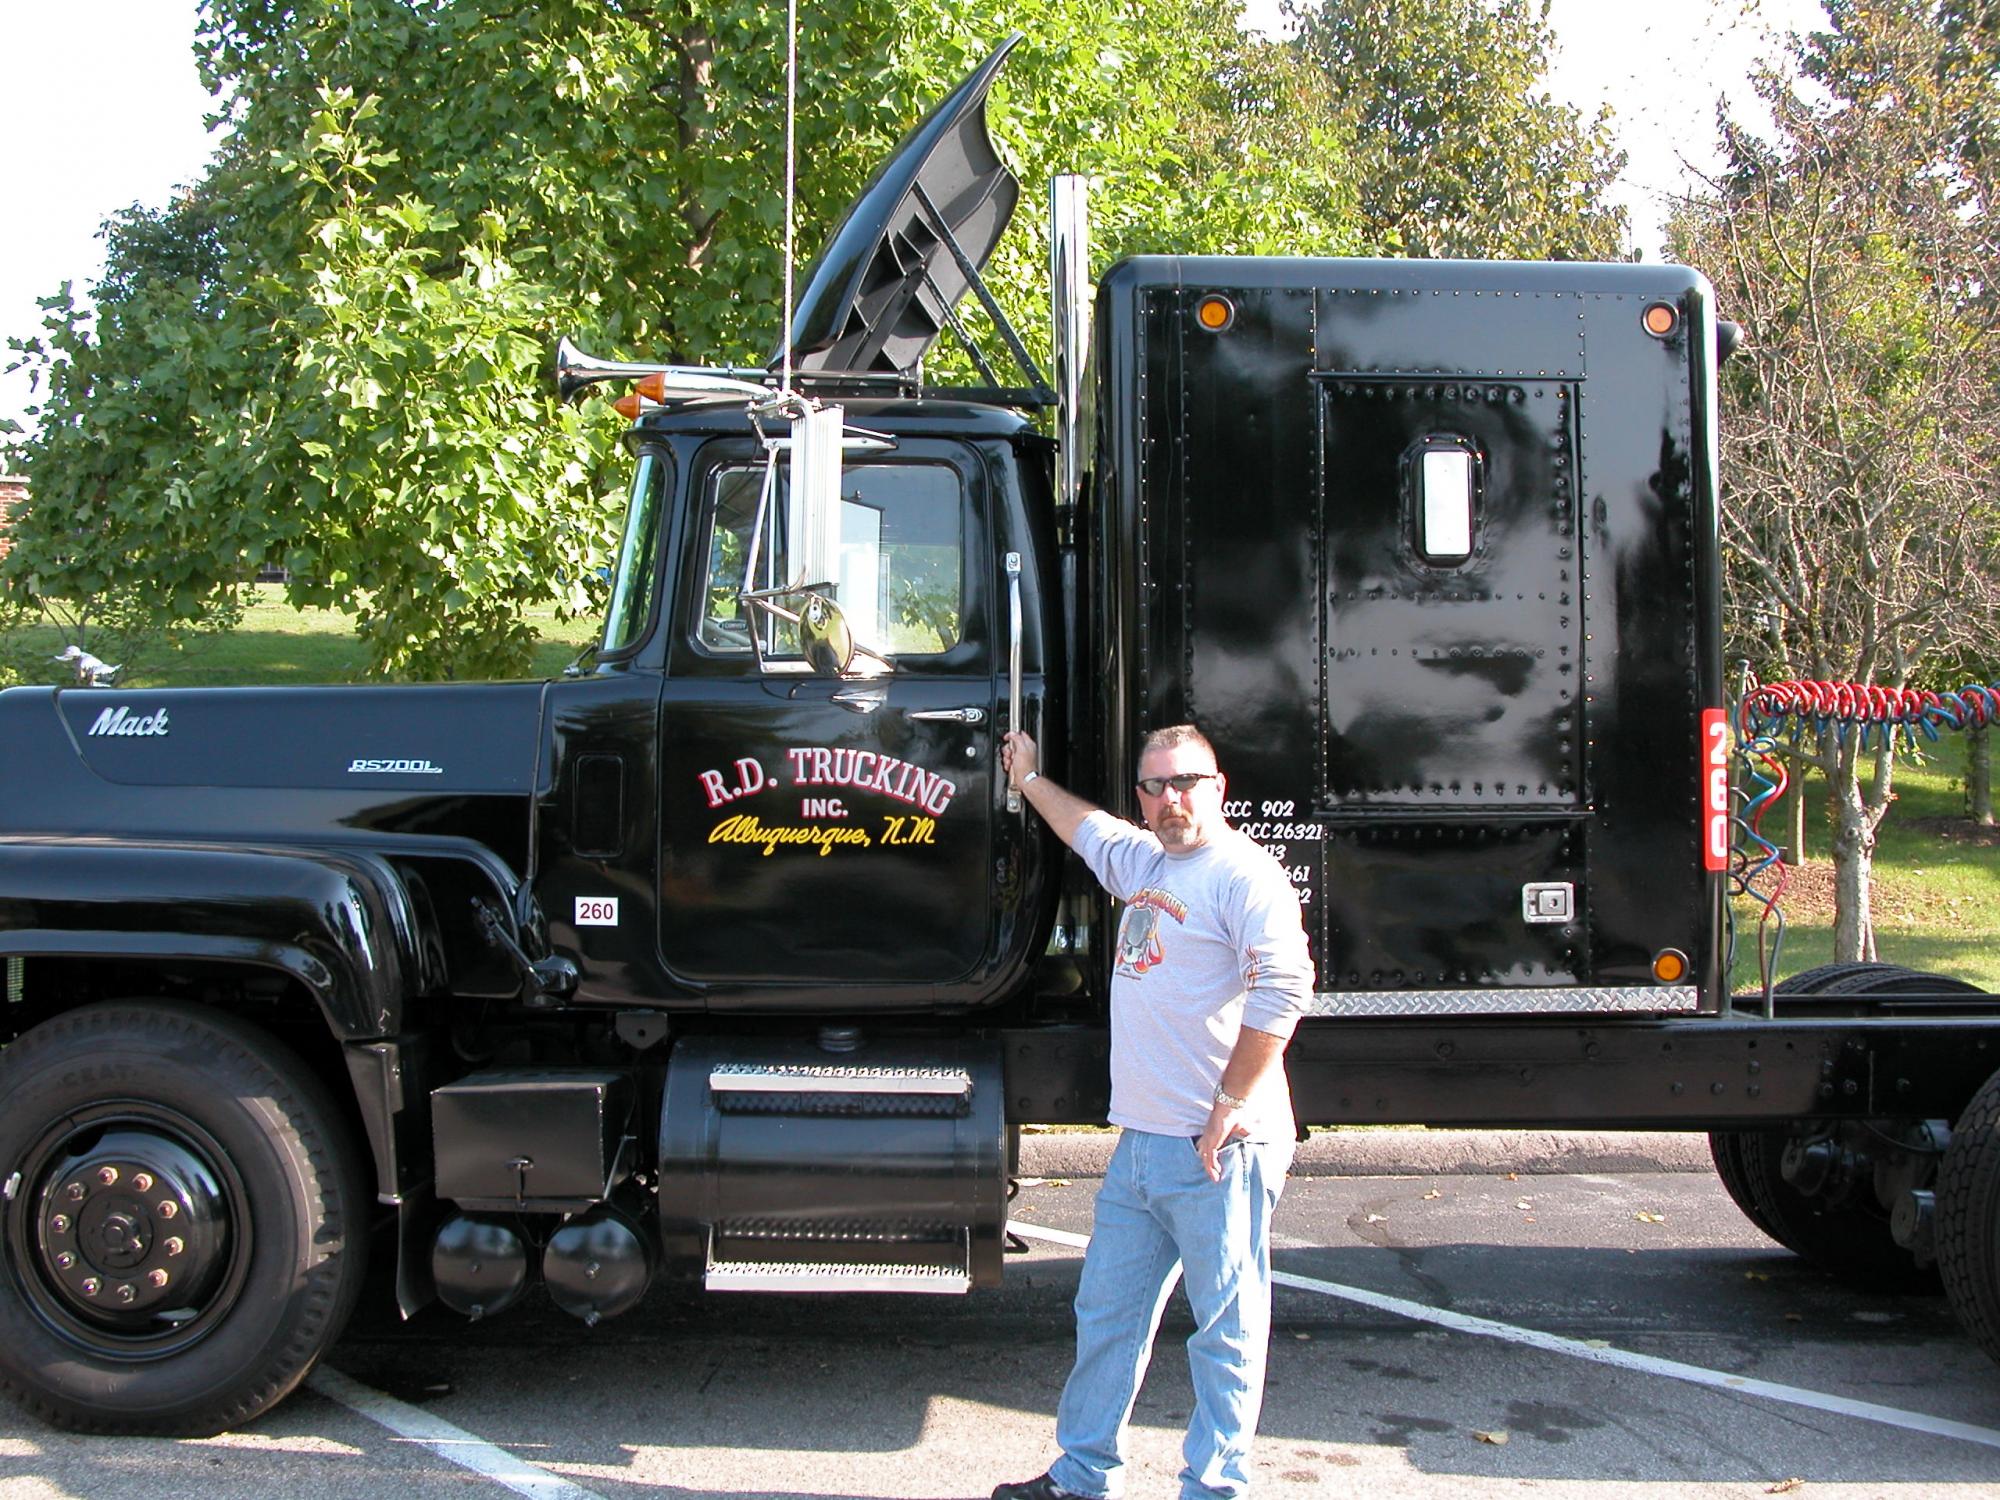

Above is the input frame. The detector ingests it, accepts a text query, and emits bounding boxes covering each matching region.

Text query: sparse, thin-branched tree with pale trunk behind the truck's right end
[1672,0,2000,958]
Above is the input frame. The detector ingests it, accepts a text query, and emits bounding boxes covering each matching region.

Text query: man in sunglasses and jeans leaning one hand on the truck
[994,724,1312,1500]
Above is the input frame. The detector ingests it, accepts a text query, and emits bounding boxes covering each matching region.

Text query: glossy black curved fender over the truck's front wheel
[0,838,444,1042]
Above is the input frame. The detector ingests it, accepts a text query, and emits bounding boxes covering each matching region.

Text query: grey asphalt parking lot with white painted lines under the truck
[0,1150,2000,1500]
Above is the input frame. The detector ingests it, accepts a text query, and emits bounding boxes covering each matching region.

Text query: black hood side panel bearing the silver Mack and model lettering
[37,682,546,794]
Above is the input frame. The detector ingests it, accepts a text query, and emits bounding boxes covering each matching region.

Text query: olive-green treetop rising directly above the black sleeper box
[1284,0,1626,260]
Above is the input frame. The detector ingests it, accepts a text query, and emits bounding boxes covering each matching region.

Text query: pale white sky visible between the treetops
[0,0,1822,444]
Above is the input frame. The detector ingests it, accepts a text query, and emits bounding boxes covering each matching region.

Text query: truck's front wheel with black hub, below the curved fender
[0,1002,368,1436]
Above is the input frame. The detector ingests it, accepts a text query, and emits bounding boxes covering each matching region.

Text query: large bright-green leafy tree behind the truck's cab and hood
[0,0,1602,676]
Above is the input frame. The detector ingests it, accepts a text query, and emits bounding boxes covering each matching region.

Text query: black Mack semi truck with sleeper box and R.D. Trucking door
[0,42,2000,1432]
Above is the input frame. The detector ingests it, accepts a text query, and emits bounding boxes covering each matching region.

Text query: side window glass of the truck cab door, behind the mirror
[696,464,966,660]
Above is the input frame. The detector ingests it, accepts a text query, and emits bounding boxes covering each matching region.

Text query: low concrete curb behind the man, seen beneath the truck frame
[1020,1128,1716,1178]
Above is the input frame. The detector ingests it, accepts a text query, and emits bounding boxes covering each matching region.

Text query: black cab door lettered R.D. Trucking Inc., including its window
[660,440,1006,1006]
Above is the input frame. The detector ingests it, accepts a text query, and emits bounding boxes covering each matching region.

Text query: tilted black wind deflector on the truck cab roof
[772,32,1022,374]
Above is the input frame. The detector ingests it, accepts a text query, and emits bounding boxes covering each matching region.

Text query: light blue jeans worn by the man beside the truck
[1048,1130,1292,1500]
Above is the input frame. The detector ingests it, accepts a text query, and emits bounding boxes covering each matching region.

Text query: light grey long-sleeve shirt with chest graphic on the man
[1074,812,1314,1140]
